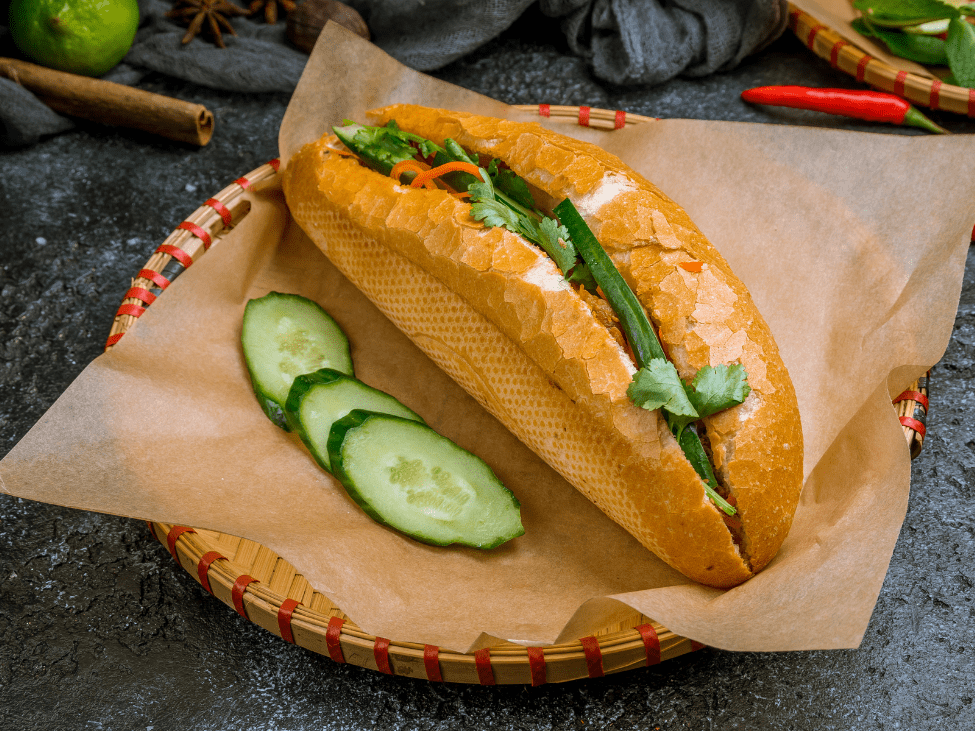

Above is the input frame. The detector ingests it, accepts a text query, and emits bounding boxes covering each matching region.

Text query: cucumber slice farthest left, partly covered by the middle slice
[240,292,353,429]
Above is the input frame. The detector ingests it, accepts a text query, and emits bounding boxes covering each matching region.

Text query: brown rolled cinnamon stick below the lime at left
[0,58,213,146]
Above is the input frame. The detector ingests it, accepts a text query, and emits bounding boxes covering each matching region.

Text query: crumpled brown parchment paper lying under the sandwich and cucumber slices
[0,25,975,651]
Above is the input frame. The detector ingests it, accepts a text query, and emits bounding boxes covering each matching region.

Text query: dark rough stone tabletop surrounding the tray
[0,11,975,731]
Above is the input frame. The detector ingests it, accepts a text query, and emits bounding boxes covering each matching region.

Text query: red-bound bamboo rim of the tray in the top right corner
[789,3,975,117]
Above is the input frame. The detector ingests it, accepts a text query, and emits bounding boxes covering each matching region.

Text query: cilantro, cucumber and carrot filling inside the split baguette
[334,121,750,532]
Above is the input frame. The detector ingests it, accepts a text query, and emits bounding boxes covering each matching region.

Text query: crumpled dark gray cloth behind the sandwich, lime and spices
[0,0,787,147]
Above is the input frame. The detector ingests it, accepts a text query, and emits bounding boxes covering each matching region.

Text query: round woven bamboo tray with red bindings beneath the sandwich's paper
[105,104,927,685]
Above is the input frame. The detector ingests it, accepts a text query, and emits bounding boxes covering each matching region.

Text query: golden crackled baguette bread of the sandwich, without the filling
[284,106,802,587]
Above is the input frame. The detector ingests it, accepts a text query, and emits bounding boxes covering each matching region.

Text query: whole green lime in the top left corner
[10,0,139,76]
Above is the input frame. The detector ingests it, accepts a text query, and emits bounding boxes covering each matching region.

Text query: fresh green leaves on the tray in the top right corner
[853,0,975,88]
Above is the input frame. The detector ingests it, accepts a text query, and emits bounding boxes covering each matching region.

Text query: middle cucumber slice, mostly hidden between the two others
[284,368,423,471]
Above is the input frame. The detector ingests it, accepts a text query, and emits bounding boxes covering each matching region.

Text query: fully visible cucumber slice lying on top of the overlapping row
[328,409,525,548]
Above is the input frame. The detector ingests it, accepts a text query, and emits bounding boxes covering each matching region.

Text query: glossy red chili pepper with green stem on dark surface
[741,86,948,134]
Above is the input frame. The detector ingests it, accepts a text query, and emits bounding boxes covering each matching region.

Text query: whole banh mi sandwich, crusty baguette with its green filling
[284,105,803,587]
